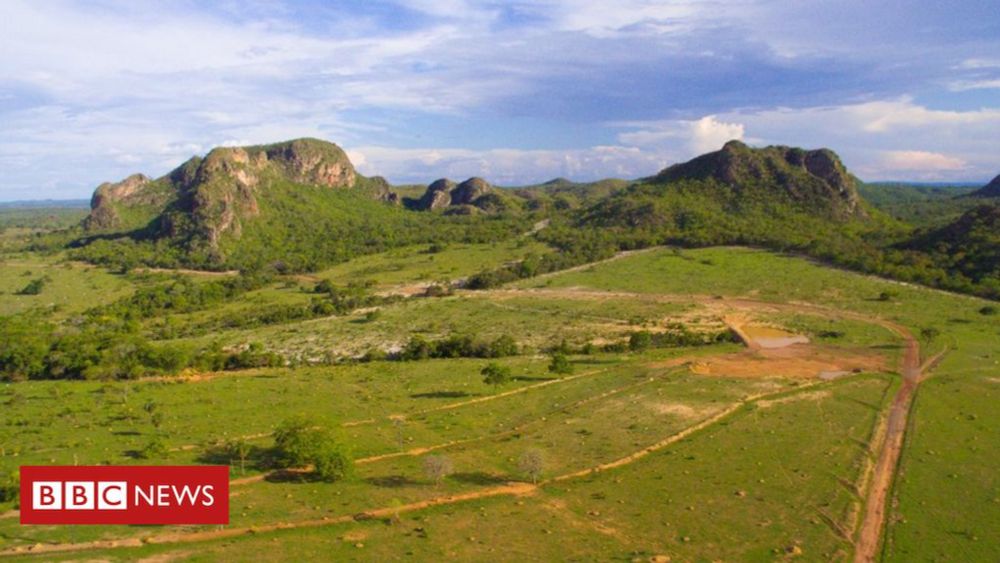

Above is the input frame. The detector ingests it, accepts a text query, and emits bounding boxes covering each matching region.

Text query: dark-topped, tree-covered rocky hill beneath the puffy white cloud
[577,141,891,248]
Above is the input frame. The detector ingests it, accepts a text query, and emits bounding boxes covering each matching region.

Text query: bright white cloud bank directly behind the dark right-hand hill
[614,98,1000,181]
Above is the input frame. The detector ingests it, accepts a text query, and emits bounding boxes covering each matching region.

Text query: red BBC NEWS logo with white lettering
[21,465,229,524]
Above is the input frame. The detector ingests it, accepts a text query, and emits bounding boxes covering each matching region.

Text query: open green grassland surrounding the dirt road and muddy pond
[0,245,1000,561]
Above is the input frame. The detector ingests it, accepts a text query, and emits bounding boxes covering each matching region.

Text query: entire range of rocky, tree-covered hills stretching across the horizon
[5,139,1000,298]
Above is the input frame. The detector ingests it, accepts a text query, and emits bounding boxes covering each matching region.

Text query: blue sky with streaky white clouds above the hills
[0,0,1000,200]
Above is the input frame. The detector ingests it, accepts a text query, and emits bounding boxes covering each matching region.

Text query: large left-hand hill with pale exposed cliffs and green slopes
[76,139,523,271]
